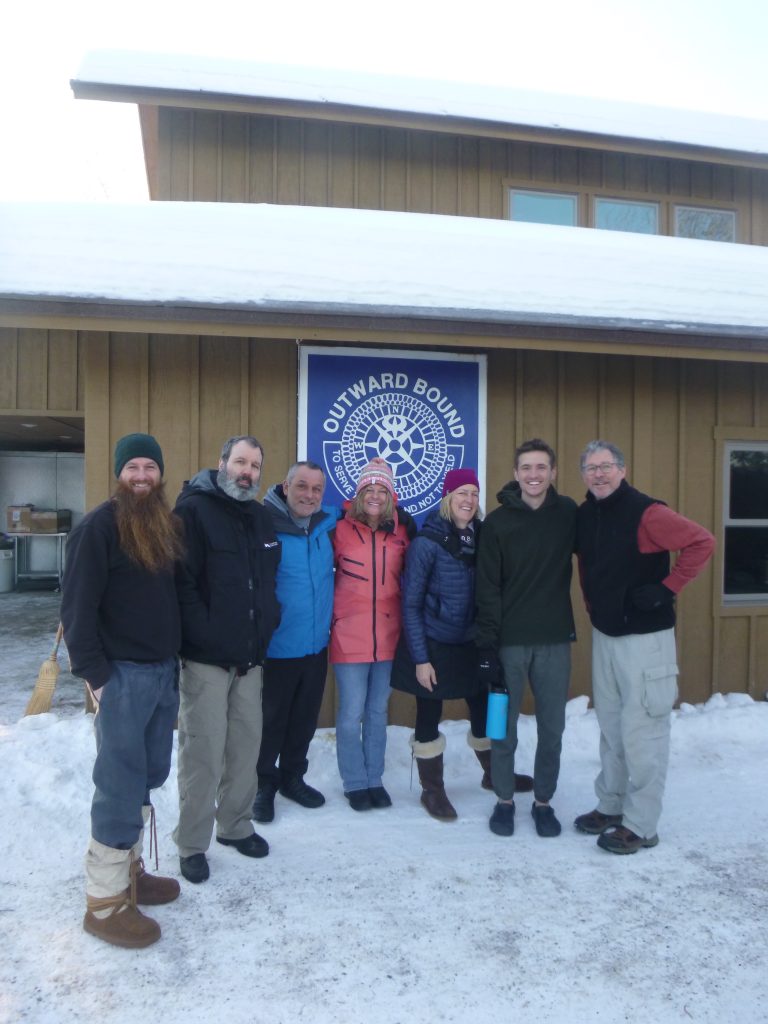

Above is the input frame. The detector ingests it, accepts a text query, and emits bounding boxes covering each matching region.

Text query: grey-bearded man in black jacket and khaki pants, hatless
[173,435,281,884]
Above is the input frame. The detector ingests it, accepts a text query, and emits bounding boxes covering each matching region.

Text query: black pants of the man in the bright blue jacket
[257,647,328,788]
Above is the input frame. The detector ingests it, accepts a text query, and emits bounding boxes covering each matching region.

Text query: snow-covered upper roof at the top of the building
[73,50,768,157]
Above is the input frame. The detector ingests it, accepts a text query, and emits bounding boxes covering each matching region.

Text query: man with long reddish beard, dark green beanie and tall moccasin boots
[61,434,182,948]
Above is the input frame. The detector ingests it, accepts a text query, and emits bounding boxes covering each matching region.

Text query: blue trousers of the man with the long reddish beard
[91,657,179,850]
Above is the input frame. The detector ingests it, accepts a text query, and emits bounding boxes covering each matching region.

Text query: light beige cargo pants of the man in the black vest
[592,629,678,839]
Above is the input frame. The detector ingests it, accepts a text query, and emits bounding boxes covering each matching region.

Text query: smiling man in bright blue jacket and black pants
[253,462,338,822]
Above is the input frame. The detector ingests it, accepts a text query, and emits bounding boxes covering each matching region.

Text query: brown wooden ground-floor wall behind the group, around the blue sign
[82,333,768,724]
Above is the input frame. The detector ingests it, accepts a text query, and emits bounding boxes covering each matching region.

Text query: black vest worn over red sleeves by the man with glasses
[577,480,675,637]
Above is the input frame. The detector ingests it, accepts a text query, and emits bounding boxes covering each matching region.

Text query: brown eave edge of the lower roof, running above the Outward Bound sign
[0,296,768,361]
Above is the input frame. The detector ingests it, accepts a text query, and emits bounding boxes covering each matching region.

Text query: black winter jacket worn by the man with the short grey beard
[175,469,281,671]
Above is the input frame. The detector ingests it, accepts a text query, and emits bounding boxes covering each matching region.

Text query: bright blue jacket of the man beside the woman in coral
[264,484,339,657]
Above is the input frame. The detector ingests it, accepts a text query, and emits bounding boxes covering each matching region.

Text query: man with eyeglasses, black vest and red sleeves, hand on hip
[574,440,715,854]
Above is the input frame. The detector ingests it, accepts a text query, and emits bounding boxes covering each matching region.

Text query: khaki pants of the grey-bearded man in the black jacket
[173,662,261,857]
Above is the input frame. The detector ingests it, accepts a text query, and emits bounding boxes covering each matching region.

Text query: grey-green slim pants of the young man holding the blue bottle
[490,643,570,803]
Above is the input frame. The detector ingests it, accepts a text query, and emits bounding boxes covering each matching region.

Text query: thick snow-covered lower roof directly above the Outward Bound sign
[0,202,768,351]
